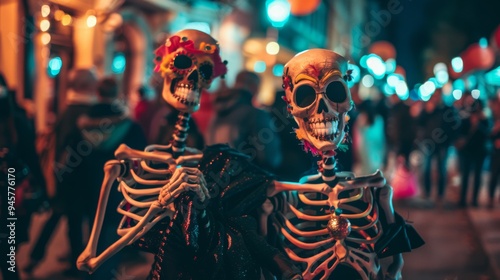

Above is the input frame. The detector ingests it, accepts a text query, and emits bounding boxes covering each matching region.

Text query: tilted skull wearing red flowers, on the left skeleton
[155,29,227,113]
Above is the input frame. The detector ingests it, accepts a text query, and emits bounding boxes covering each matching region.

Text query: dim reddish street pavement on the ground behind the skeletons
[9,187,500,280]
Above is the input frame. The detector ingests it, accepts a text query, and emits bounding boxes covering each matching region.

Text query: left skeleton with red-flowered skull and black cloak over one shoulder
[77,30,300,280]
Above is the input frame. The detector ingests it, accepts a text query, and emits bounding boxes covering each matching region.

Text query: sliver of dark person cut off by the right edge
[488,98,500,208]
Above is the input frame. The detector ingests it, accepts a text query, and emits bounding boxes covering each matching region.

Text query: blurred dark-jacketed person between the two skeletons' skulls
[205,71,282,171]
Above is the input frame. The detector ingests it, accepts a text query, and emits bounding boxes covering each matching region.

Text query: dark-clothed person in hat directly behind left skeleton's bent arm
[66,77,147,279]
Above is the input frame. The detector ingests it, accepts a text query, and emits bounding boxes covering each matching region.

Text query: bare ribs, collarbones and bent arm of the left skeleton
[77,142,205,273]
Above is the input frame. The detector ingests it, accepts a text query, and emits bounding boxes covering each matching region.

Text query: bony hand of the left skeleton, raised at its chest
[158,167,210,206]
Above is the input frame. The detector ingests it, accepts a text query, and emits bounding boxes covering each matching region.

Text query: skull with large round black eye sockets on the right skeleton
[283,49,353,152]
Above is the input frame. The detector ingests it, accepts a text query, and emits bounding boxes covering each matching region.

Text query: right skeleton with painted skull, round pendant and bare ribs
[268,49,423,280]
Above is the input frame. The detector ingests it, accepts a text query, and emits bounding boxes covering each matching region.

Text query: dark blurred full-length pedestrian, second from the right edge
[456,97,490,207]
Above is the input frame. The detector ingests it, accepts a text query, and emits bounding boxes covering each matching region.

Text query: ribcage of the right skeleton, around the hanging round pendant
[277,173,385,279]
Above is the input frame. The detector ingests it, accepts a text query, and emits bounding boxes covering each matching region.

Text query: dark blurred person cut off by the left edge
[0,73,45,280]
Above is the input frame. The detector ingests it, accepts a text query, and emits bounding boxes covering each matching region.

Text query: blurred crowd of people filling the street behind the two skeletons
[0,69,500,279]
